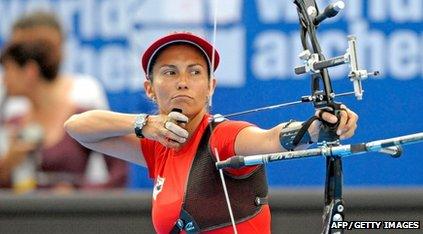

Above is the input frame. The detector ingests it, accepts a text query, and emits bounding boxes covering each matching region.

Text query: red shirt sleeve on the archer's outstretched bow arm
[210,121,257,177]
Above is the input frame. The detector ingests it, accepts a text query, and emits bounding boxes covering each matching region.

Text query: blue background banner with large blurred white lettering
[0,0,423,187]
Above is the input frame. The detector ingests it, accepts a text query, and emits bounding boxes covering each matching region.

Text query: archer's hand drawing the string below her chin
[142,111,189,148]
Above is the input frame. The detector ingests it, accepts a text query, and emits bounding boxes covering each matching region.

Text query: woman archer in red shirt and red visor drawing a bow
[65,33,358,233]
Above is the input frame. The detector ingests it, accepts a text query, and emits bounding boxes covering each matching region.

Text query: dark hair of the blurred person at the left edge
[0,40,60,81]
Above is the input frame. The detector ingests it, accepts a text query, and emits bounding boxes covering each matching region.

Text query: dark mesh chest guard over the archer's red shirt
[172,123,268,233]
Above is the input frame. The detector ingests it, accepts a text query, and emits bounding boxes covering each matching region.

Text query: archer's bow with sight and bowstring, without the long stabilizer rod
[209,0,378,233]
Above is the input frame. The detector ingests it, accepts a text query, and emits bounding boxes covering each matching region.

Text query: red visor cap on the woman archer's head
[141,32,220,79]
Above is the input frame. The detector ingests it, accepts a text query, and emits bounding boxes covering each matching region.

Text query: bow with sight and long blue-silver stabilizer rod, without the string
[210,0,423,233]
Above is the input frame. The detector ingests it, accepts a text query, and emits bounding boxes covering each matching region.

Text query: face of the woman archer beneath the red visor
[145,45,215,118]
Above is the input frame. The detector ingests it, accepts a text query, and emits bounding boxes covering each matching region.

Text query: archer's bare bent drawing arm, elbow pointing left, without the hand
[64,110,145,165]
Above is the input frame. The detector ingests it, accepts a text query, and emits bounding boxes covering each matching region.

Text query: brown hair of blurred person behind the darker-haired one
[12,11,63,37]
